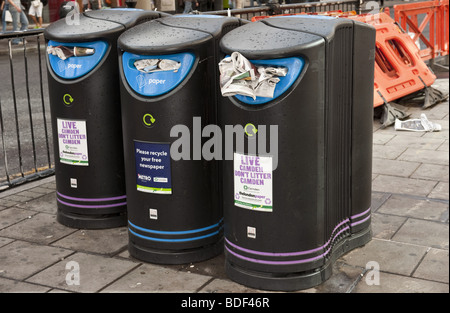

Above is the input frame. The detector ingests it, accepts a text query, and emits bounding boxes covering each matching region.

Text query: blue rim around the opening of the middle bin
[122,52,196,97]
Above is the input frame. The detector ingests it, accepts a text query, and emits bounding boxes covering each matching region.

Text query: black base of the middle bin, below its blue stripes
[128,238,224,265]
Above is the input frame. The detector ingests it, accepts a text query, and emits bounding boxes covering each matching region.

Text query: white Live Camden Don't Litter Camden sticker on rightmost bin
[234,153,273,212]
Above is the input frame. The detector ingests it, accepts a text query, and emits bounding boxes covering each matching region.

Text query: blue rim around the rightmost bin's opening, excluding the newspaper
[234,57,305,105]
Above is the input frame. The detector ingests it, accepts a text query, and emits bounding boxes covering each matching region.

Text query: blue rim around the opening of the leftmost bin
[48,40,109,79]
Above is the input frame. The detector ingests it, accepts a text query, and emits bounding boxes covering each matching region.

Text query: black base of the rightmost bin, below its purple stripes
[225,227,372,291]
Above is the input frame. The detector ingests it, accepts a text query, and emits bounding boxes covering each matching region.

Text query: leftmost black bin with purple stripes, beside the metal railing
[44,9,168,228]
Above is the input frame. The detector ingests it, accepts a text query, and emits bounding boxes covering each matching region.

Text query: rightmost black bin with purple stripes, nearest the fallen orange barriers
[219,16,375,291]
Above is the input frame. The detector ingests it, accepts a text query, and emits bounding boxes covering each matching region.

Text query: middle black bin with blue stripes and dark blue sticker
[118,15,246,264]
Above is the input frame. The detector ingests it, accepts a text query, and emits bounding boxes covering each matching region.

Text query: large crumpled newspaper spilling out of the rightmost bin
[219,52,287,100]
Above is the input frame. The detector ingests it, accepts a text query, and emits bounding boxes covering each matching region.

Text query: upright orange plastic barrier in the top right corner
[394,0,449,60]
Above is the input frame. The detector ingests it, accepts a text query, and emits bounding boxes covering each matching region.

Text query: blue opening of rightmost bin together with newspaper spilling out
[219,52,305,105]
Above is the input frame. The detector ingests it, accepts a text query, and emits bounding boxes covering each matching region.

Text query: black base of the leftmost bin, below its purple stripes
[56,210,128,229]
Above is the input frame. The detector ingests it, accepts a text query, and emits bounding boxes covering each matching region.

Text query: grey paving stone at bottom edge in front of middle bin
[102,264,211,293]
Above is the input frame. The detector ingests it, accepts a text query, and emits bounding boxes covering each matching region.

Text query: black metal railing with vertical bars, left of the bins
[0,29,54,190]
